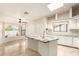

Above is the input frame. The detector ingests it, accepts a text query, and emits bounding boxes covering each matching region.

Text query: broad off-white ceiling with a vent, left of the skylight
[0,3,50,22]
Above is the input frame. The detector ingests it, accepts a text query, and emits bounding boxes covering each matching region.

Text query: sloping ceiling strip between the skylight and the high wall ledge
[47,3,79,16]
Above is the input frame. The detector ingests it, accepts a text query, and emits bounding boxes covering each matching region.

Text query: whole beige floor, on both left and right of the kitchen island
[0,42,79,56]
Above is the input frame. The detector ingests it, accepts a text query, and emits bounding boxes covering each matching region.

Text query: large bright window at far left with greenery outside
[5,24,18,37]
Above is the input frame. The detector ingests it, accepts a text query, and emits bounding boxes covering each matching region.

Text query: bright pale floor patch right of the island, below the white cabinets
[57,45,79,56]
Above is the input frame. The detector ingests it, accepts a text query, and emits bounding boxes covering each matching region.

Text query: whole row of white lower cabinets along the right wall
[58,36,79,48]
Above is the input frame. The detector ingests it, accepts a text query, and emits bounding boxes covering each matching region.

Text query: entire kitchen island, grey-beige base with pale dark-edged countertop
[27,36,58,56]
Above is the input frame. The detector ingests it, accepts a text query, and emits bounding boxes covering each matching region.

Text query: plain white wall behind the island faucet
[26,18,47,36]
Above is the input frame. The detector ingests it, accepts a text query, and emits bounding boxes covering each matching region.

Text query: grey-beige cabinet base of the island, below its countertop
[28,38,57,56]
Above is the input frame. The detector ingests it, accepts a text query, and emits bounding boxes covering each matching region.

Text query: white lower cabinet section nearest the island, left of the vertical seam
[58,36,72,46]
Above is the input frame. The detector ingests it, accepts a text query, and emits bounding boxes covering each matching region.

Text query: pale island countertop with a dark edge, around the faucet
[27,36,58,43]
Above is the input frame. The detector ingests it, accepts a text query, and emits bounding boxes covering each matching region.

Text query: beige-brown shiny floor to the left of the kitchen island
[0,42,40,56]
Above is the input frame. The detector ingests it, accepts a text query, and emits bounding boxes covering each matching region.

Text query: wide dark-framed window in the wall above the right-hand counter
[53,22,68,32]
